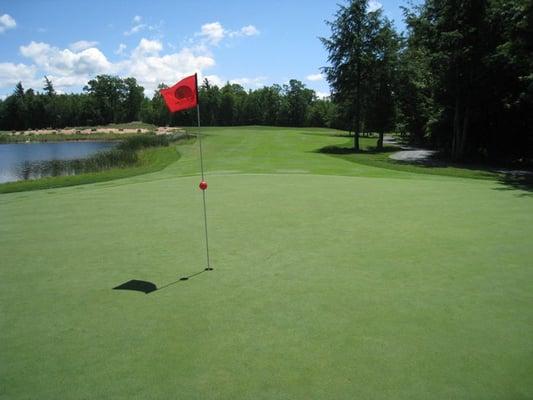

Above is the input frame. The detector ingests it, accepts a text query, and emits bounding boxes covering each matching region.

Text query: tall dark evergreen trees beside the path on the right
[321,0,533,162]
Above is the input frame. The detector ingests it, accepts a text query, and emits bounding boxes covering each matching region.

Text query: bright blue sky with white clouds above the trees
[0,0,414,97]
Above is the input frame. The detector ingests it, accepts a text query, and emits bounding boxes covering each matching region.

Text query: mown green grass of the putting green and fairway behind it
[0,127,533,400]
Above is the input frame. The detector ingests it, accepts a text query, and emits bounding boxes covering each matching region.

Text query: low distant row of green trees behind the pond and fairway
[0,75,336,130]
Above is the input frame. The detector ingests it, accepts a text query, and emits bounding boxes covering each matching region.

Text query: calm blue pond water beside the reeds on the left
[0,141,117,183]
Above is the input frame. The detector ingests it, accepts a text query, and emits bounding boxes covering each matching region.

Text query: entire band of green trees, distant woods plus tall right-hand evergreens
[0,0,533,162]
